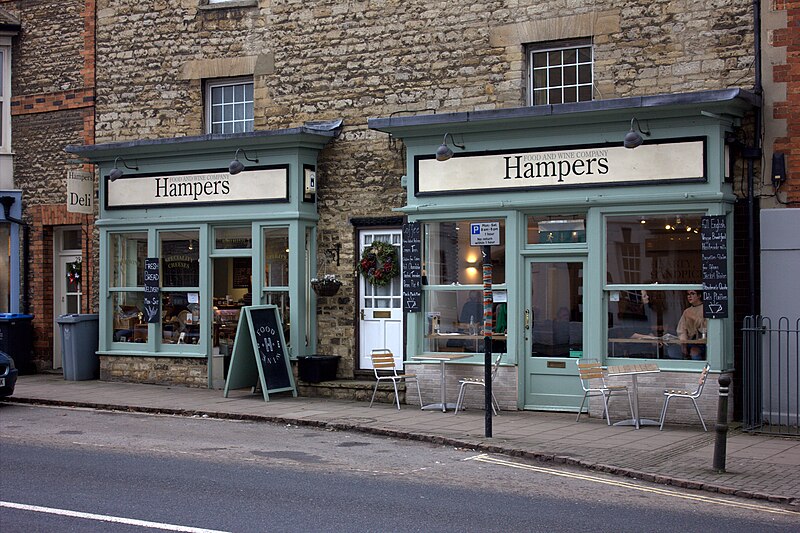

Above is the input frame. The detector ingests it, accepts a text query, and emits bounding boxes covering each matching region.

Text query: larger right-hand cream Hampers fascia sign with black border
[416,139,706,195]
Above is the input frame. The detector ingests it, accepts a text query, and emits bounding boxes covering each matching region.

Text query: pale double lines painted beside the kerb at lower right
[464,453,800,516]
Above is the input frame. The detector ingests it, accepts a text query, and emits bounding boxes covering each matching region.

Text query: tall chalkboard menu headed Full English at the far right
[700,215,728,318]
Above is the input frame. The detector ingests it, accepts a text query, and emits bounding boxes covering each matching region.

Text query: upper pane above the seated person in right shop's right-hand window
[606,214,702,285]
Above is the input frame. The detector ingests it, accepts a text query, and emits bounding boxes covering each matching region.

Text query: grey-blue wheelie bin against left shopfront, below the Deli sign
[56,314,100,381]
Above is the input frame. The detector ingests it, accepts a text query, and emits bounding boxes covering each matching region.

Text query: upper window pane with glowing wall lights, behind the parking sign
[423,220,506,285]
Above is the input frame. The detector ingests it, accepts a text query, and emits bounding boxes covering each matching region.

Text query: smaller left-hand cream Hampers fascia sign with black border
[105,165,289,209]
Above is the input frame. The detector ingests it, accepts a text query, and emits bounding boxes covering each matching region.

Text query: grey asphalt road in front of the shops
[0,404,800,533]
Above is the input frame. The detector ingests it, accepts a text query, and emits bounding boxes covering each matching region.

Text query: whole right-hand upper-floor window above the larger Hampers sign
[528,39,593,105]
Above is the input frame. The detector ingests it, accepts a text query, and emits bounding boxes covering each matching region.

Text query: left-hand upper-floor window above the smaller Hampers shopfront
[206,78,253,133]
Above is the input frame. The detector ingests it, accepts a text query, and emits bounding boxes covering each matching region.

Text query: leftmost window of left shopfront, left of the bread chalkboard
[108,232,147,342]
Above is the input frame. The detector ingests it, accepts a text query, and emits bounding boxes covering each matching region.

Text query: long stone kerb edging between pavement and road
[9,397,800,506]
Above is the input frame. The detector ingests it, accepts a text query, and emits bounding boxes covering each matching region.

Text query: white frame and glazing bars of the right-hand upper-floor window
[527,39,594,106]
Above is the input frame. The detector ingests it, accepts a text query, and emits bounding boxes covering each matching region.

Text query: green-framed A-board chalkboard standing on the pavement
[225,305,297,401]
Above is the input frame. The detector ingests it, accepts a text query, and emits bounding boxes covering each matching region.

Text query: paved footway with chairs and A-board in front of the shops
[6,374,800,508]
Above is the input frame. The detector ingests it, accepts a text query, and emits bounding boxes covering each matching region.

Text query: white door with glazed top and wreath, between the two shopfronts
[358,229,403,369]
